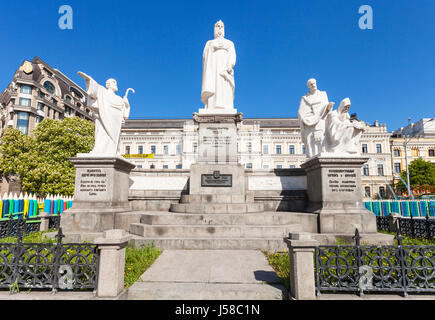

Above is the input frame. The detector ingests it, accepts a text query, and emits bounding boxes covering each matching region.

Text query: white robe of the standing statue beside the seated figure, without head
[298,90,329,158]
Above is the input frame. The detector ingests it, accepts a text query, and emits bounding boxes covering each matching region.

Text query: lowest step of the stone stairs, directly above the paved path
[130,236,288,252]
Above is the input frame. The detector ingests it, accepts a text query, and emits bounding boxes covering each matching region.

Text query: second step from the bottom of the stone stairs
[130,223,302,238]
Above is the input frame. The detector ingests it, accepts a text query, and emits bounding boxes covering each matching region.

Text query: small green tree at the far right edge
[397,158,435,190]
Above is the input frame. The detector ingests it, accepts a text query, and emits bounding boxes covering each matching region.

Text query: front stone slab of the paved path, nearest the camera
[127,282,287,300]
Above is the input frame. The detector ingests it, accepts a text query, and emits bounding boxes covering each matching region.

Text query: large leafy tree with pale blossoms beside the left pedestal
[0,117,94,195]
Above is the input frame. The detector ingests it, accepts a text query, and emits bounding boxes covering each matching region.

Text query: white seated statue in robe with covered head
[325,98,366,155]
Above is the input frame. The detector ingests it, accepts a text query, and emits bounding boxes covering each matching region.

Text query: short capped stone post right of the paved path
[285,232,318,300]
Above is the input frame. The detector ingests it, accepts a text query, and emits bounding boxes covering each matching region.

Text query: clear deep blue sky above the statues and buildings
[0,0,435,130]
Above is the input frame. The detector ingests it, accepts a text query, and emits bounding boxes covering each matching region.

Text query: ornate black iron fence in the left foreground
[0,228,99,292]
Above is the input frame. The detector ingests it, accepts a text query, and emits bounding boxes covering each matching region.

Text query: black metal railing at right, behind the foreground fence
[376,215,435,239]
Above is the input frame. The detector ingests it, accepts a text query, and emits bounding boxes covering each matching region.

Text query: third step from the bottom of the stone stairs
[140,212,317,232]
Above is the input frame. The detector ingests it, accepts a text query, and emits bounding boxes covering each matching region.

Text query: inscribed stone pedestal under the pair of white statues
[301,156,377,234]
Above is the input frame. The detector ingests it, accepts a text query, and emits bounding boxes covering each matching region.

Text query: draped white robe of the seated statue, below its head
[326,108,364,155]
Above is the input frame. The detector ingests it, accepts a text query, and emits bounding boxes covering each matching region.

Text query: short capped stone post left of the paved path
[94,229,131,298]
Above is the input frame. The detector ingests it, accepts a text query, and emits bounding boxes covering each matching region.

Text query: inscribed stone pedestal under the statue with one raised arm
[61,154,135,232]
